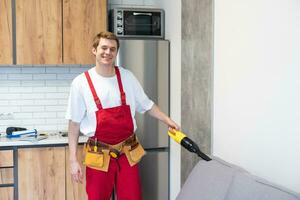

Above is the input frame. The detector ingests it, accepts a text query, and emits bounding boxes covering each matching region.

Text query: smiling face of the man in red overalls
[92,38,118,67]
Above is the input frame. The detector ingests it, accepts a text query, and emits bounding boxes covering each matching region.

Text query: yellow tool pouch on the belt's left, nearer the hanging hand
[83,144,110,172]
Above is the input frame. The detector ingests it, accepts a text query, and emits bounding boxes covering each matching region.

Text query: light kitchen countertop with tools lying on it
[0,134,88,147]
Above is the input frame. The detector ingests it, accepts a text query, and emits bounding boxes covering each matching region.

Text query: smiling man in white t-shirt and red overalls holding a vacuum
[66,32,180,200]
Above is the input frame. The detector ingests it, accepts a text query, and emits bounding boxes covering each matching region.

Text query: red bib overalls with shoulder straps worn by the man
[85,67,142,200]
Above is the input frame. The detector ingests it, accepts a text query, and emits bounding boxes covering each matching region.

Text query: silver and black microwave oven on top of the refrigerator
[109,8,164,39]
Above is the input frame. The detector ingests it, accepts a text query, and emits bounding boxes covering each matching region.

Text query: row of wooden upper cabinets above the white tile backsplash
[0,0,107,64]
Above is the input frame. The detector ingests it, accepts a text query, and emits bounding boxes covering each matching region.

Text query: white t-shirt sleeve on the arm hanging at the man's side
[65,80,86,123]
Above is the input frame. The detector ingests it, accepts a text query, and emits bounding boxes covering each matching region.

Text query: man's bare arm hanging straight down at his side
[68,120,83,183]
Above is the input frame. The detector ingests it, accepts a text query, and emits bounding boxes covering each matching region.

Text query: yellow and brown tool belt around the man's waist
[83,134,146,172]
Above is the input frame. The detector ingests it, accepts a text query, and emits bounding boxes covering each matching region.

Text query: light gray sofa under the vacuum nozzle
[176,157,300,200]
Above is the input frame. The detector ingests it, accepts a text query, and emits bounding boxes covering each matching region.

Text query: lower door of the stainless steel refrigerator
[140,151,169,200]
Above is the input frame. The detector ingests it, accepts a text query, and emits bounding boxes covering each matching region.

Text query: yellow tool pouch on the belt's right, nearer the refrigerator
[123,138,146,166]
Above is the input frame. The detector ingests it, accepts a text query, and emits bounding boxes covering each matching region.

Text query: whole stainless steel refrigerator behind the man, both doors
[116,39,169,200]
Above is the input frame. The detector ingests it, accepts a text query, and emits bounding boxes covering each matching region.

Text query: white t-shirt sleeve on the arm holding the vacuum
[131,73,154,113]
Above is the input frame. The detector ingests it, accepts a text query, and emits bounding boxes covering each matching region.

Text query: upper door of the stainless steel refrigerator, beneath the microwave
[116,40,169,148]
